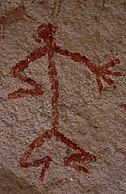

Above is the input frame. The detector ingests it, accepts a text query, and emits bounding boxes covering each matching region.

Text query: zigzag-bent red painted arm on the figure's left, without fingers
[8,47,47,99]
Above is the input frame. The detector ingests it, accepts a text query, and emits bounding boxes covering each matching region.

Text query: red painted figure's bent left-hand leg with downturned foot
[19,130,53,181]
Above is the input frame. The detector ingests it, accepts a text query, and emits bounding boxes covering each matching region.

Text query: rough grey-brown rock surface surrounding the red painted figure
[0,0,126,194]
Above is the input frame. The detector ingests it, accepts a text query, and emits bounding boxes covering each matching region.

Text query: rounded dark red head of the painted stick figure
[37,23,57,41]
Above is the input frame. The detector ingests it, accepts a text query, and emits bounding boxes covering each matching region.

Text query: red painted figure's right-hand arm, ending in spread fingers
[56,46,126,93]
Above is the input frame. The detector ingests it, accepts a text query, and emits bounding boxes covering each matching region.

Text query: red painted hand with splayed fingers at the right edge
[94,59,126,93]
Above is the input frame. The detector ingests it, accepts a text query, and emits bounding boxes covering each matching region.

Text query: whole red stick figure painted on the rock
[8,23,126,181]
